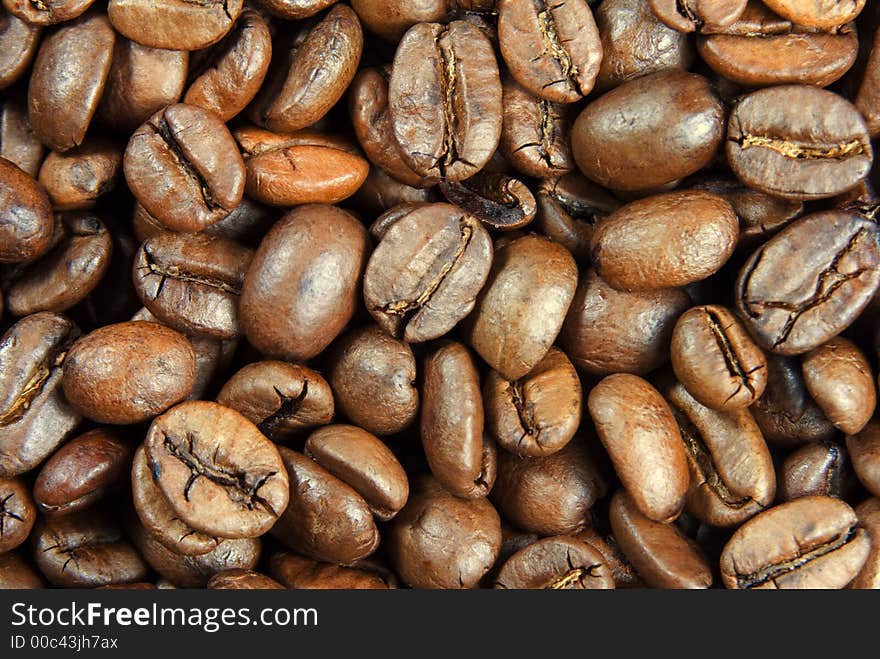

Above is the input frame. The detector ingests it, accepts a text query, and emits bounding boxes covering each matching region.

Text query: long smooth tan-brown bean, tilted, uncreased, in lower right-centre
[587,373,690,522]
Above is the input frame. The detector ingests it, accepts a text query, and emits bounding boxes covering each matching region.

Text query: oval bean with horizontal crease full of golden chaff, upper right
[727,85,873,200]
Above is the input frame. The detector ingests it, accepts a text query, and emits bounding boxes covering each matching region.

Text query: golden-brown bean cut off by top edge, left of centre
[107,0,243,50]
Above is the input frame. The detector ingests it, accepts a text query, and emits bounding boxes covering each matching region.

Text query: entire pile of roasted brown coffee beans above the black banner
[0,0,880,589]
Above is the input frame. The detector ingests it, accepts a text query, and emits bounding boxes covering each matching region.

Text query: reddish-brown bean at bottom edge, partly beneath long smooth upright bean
[608,490,712,589]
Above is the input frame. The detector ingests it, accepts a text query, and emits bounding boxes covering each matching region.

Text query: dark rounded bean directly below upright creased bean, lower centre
[492,436,608,535]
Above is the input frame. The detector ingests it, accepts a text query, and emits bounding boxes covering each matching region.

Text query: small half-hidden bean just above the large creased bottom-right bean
[777,441,855,501]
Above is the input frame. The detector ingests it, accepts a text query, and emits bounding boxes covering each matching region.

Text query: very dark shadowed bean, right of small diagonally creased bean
[751,355,835,445]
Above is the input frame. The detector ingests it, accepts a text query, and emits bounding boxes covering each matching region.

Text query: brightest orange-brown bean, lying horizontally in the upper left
[235,127,370,206]
